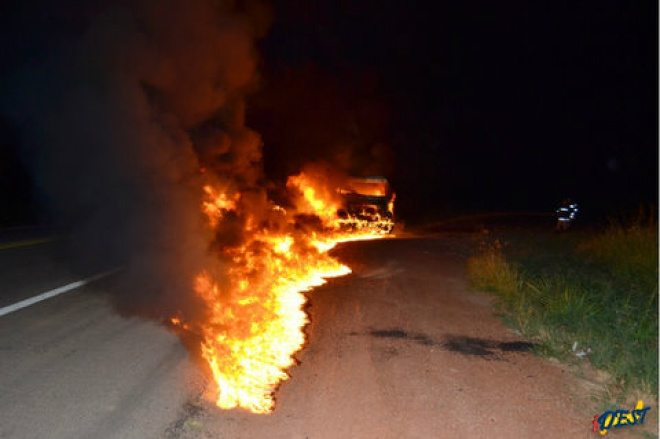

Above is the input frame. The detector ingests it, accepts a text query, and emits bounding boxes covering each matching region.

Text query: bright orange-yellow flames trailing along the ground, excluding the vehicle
[180,170,394,413]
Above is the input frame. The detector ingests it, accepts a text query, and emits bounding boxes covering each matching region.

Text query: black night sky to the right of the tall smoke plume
[0,0,658,227]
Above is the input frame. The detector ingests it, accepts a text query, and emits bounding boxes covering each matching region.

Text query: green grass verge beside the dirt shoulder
[468,209,658,395]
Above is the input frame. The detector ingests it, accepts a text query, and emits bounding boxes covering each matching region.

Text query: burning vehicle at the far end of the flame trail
[337,177,396,233]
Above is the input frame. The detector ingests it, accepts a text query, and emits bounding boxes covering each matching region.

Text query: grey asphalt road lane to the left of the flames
[0,236,204,439]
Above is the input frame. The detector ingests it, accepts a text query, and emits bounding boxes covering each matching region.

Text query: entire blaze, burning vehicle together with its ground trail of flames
[170,167,394,414]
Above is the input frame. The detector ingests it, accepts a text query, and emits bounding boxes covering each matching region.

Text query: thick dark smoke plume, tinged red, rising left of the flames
[0,0,269,316]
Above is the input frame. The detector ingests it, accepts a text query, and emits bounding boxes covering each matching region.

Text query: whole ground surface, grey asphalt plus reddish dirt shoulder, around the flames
[0,234,640,439]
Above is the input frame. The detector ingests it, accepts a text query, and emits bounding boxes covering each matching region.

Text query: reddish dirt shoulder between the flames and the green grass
[177,235,657,439]
